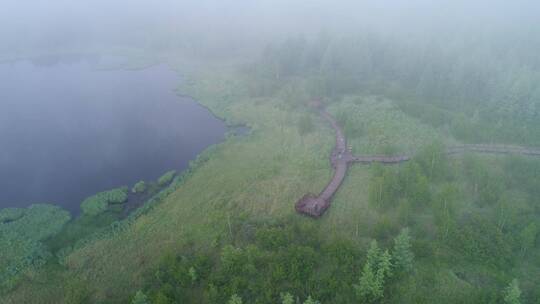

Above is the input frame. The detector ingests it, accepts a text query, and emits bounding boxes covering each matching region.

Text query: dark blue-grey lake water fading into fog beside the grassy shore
[0,54,226,214]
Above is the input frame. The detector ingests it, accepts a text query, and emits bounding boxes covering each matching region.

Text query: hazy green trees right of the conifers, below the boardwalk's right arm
[369,144,540,303]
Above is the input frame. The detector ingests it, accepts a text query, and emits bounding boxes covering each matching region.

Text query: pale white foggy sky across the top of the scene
[0,0,540,52]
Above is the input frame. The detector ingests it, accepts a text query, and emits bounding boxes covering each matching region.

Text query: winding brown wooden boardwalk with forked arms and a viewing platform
[295,110,540,217]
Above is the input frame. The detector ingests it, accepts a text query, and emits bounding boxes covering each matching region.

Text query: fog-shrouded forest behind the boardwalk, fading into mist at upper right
[247,30,540,145]
